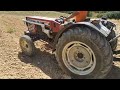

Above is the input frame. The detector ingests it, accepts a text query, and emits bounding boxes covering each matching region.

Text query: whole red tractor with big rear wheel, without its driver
[20,16,119,79]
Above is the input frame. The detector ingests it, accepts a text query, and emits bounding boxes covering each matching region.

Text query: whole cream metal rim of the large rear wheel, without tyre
[62,41,96,75]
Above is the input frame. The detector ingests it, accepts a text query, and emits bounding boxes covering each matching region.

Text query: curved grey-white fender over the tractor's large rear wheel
[52,22,110,50]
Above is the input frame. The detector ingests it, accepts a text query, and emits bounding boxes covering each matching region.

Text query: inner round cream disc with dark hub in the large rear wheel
[67,44,91,70]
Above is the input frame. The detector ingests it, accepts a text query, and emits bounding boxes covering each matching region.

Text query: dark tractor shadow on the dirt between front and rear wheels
[18,48,64,79]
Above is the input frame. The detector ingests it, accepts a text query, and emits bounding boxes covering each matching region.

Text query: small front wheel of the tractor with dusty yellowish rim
[19,35,36,56]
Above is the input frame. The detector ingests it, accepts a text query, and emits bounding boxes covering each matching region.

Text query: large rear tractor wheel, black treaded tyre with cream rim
[55,27,113,79]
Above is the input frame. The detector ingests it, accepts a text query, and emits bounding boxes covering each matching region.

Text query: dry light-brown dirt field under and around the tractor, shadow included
[0,12,120,79]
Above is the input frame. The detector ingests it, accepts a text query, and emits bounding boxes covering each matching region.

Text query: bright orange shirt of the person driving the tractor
[74,11,88,22]
